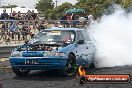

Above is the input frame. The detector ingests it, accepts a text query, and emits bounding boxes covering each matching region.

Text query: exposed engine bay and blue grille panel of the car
[15,44,75,57]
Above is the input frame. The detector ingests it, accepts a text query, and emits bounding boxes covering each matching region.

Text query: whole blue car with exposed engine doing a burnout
[9,28,95,76]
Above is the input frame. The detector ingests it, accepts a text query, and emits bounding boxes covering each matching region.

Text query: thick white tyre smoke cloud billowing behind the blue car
[89,6,132,67]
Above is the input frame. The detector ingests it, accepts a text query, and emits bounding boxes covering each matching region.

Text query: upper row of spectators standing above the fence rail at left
[0,10,38,29]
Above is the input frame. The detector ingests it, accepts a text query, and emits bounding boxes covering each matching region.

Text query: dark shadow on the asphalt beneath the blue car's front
[13,71,75,81]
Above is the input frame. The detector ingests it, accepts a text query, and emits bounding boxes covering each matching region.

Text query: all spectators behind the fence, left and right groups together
[0,10,94,44]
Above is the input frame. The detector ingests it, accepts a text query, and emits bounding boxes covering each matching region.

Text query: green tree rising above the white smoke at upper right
[75,0,132,17]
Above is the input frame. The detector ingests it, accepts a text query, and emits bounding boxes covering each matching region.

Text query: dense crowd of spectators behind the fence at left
[0,10,38,40]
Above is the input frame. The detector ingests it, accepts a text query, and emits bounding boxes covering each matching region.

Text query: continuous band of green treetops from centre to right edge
[36,0,132,19]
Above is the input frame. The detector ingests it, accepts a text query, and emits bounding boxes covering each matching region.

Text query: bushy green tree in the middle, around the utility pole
[35,0,73,19]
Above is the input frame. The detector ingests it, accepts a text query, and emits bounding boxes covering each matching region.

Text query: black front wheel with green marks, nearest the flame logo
[63,54,77,77]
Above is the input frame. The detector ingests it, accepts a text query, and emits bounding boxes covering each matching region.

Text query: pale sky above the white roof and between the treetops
[0,0,77,8]
